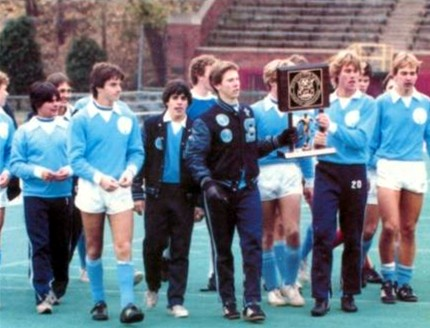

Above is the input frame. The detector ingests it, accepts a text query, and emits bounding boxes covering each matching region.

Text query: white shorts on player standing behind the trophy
[258,163,303,201]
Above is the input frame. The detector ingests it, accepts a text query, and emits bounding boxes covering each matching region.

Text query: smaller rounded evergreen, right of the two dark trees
[66,36,107,92]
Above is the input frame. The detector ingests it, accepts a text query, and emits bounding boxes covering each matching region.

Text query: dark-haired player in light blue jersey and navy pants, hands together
[11,82,72,314]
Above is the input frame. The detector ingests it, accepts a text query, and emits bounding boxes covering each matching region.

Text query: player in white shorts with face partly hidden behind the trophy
[251,59,313,306]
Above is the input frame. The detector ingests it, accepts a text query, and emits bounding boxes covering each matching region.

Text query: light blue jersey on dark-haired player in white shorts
[68,100,144,183]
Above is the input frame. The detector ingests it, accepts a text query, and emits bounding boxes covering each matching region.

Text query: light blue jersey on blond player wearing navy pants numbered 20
[318,91,376,164]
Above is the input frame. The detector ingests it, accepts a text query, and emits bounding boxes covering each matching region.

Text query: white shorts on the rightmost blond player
[376,159,427,194]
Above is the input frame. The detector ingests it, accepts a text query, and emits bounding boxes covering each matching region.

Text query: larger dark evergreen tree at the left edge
[0,16,44,94]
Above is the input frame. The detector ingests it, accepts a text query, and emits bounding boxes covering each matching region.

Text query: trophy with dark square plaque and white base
[277,64,336,158]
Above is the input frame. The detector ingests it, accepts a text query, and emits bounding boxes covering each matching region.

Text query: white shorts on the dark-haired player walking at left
[75,179,134,214]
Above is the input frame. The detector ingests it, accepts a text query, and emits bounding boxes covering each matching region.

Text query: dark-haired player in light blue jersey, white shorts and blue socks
[69,62,144,323]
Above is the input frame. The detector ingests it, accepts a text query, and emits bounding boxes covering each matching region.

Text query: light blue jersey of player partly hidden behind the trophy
[251,96,314,179]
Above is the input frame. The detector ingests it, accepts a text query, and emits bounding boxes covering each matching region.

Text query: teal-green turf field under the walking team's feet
[0,165,430,328]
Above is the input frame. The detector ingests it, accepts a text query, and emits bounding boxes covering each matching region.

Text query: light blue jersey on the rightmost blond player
[371,90,430,165]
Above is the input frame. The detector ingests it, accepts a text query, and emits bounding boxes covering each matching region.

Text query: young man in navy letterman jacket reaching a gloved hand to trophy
[186,61,296,321]
